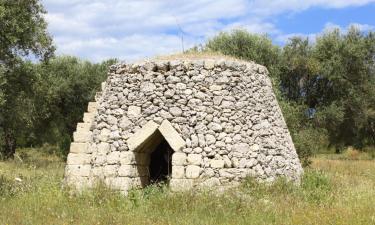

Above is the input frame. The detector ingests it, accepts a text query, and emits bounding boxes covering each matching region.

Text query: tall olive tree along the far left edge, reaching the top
[0,0,54,158]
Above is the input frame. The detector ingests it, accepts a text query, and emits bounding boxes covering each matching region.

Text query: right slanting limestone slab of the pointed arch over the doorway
[159,120,186,152]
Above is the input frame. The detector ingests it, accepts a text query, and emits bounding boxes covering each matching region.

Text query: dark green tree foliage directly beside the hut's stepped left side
[27,56,115,154]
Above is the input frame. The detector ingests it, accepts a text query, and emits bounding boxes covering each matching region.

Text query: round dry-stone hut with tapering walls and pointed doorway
[65,58,303,193]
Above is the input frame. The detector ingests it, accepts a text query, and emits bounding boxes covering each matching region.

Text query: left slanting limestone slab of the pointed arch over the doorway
[127,121,159,151]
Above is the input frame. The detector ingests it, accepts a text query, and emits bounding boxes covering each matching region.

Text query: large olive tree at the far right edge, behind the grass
[314,27,375,147]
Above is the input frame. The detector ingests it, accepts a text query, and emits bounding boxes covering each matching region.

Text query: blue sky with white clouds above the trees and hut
[42,0,375,62]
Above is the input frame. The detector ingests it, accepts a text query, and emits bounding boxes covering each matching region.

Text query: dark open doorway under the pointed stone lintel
[149,138,173,184]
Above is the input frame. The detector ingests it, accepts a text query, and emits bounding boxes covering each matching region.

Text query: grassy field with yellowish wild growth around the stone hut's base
[0,150,375,225]
